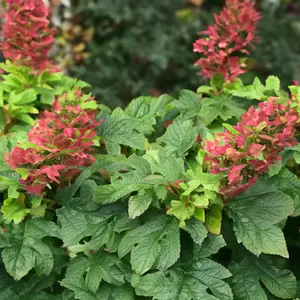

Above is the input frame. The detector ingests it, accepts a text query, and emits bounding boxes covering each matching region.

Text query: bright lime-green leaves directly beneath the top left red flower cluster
[0,61,66,135]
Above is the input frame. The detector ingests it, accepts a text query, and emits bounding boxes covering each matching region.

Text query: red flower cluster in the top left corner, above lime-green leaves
[1,0,56,71]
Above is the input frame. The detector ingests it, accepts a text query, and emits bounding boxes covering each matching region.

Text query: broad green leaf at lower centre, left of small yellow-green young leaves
[118,215,180,274]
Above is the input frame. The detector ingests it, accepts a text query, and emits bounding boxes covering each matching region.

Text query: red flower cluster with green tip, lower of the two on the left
[5,90,102,195]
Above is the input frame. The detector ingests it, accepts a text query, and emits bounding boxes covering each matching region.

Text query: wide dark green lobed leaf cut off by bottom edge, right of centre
[131,234,233,300]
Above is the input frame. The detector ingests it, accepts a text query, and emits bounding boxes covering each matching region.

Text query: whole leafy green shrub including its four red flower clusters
[0,0,300,300]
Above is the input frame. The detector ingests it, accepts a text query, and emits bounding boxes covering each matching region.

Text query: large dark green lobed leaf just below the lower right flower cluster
[227,181,294,257]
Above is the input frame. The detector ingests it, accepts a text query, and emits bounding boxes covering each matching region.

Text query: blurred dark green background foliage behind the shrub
[2,0,300,107]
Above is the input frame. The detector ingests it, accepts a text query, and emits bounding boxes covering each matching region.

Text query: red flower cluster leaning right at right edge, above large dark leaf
[205,97,299,197]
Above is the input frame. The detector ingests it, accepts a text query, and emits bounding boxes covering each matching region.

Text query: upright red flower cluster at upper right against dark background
[194,0,260,82]
